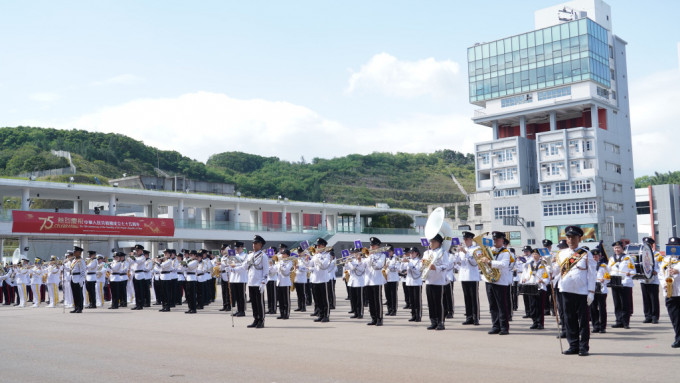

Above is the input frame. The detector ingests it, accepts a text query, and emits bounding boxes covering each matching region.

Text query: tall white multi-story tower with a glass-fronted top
[468,0,637,245]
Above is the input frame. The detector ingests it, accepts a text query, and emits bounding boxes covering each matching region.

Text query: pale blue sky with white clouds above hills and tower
[0,0,680,176]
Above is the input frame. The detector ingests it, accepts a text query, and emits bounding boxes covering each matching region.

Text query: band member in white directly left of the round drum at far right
[609,241,635,329]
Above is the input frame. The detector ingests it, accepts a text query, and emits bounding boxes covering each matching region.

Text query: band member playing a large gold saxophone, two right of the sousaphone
[483,231,512,335]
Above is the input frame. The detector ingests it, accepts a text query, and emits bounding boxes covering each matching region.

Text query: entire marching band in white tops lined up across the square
[0,226,680,356]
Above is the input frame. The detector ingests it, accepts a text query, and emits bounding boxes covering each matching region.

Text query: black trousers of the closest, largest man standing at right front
[561,292,590,351]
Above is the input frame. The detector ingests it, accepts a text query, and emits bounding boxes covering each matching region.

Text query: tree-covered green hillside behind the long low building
[0,127,474,211]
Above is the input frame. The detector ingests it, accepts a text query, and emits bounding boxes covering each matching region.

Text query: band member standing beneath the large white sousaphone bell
[423,234,449,330]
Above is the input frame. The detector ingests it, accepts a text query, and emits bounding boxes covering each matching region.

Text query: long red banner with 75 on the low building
[12,210,175,237]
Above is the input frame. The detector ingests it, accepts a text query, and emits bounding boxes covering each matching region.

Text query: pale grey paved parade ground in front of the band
[0,281,680,383]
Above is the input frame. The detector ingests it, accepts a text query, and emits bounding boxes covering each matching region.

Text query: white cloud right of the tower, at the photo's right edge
[630,70,680,177]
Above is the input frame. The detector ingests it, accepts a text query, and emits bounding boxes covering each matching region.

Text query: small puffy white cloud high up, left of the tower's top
[347,53,460,98]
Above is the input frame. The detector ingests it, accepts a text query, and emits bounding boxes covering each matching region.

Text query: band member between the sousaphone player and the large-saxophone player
[457,231,479,326]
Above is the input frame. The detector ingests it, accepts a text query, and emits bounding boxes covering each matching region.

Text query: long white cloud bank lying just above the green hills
[42,92,480,166]
